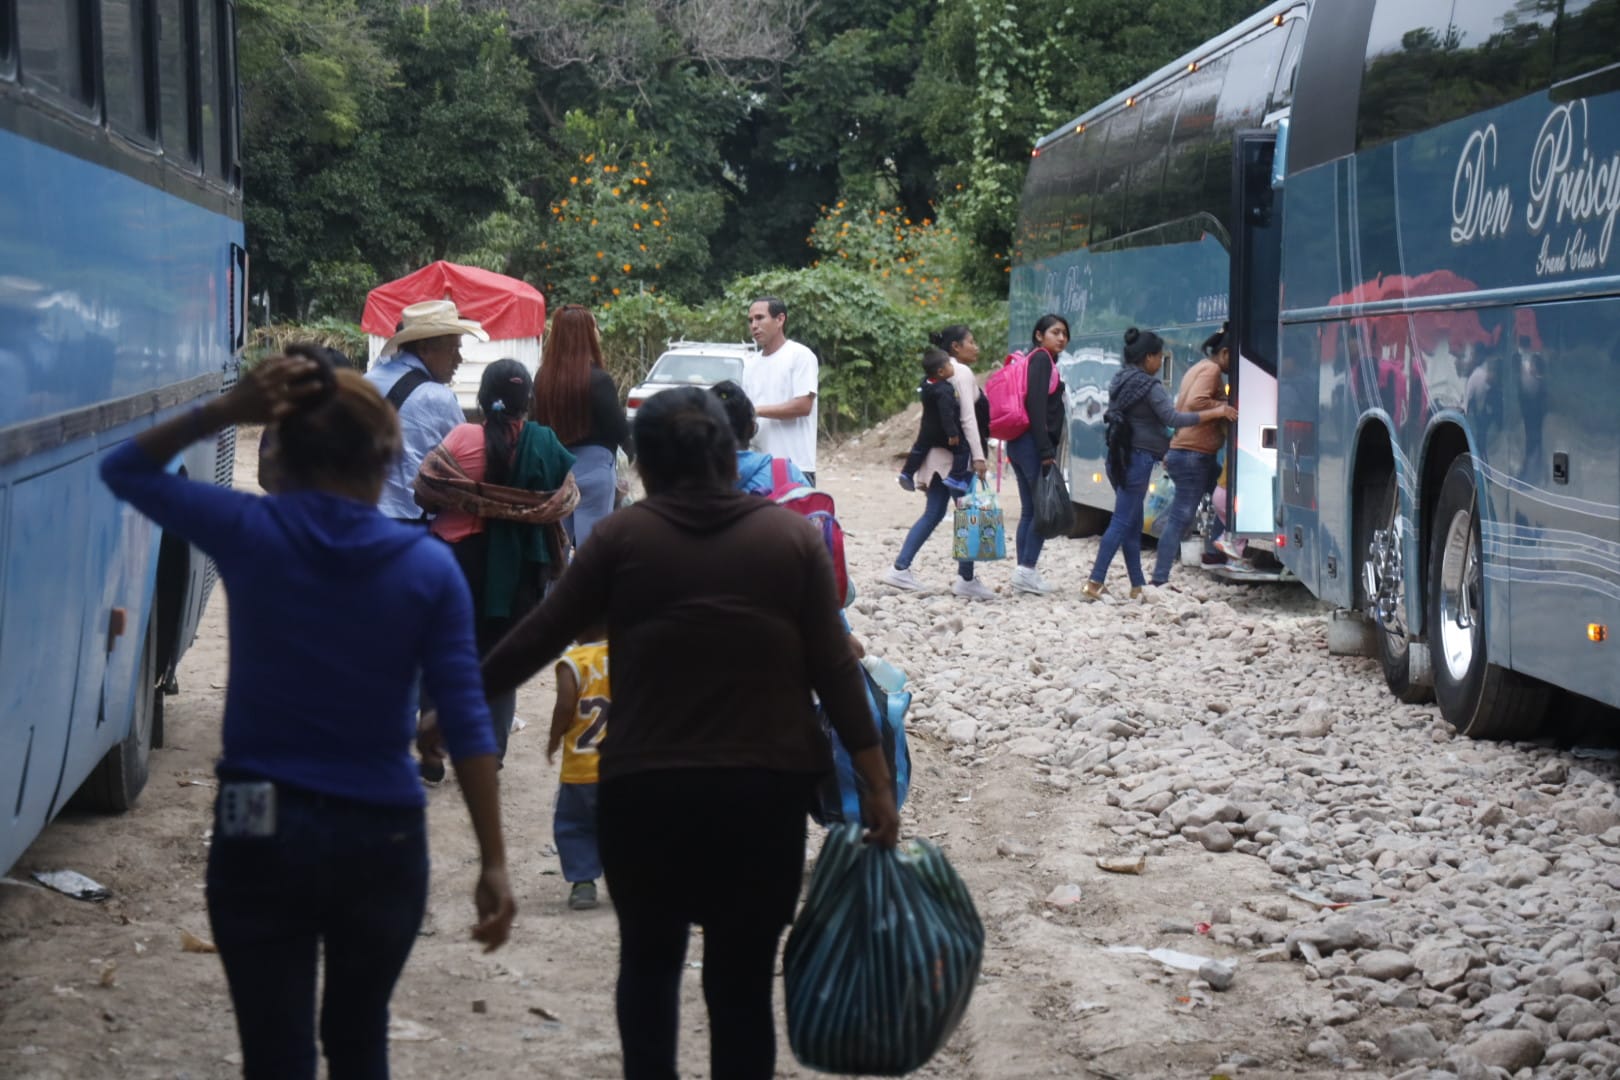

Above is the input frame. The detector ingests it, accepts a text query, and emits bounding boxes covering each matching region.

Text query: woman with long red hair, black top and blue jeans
[531,304,630,547]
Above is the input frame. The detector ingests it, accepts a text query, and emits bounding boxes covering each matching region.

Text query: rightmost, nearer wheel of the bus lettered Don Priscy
[1424,453,1550,738]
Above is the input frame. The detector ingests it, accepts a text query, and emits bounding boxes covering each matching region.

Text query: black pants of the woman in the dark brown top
[598,769,816,1080]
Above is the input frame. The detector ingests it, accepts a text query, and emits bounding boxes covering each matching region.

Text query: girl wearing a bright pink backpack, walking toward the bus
[985,314,1069,594]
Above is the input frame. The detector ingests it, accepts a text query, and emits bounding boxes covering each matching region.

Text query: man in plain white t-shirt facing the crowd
[742,296,821,484]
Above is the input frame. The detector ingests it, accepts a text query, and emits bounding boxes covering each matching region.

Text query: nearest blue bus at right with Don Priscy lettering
[1276,0,1620,737]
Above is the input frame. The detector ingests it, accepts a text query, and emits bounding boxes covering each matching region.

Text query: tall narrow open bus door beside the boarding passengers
[1226,131,1281,546]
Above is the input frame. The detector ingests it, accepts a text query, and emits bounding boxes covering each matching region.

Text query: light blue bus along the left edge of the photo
[0,0,246,870]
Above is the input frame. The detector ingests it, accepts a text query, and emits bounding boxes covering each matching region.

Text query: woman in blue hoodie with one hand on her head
[102,356,514,1080]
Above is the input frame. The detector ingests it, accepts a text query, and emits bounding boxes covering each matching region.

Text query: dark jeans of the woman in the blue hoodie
[207,776,428,1080]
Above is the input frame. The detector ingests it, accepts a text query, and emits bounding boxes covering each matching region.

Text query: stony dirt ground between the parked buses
[0,411,1620,1080]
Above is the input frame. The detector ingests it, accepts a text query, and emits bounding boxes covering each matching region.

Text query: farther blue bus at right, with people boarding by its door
[1009,0,1307,573]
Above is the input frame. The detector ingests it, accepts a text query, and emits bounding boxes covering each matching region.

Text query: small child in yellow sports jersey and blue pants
[546,627,612,912]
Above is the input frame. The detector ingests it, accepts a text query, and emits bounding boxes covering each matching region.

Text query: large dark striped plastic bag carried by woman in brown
[782,824,985,1077]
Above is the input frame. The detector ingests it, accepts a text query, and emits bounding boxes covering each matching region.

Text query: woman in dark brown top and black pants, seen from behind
[483,387,899,1080]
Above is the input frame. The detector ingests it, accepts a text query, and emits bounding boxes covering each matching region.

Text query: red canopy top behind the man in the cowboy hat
[360,261,546,342]
